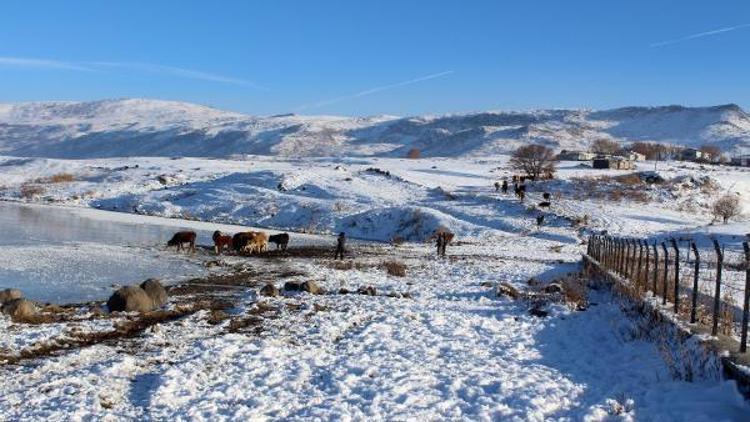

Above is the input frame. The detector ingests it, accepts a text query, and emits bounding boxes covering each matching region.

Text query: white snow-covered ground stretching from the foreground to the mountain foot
[0,152,750,421]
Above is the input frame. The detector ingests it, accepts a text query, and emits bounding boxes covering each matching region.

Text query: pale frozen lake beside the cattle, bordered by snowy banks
[0,203,210,303]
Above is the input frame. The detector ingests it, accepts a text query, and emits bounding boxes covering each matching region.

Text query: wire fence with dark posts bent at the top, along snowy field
[587,235,750,353]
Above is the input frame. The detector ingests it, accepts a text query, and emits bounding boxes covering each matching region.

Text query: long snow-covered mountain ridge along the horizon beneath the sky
[0,99,750,158]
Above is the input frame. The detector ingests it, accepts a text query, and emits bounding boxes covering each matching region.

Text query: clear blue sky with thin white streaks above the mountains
[0,0,750,115]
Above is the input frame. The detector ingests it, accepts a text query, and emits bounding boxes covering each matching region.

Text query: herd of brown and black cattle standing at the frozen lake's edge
[167,230,289,255]
